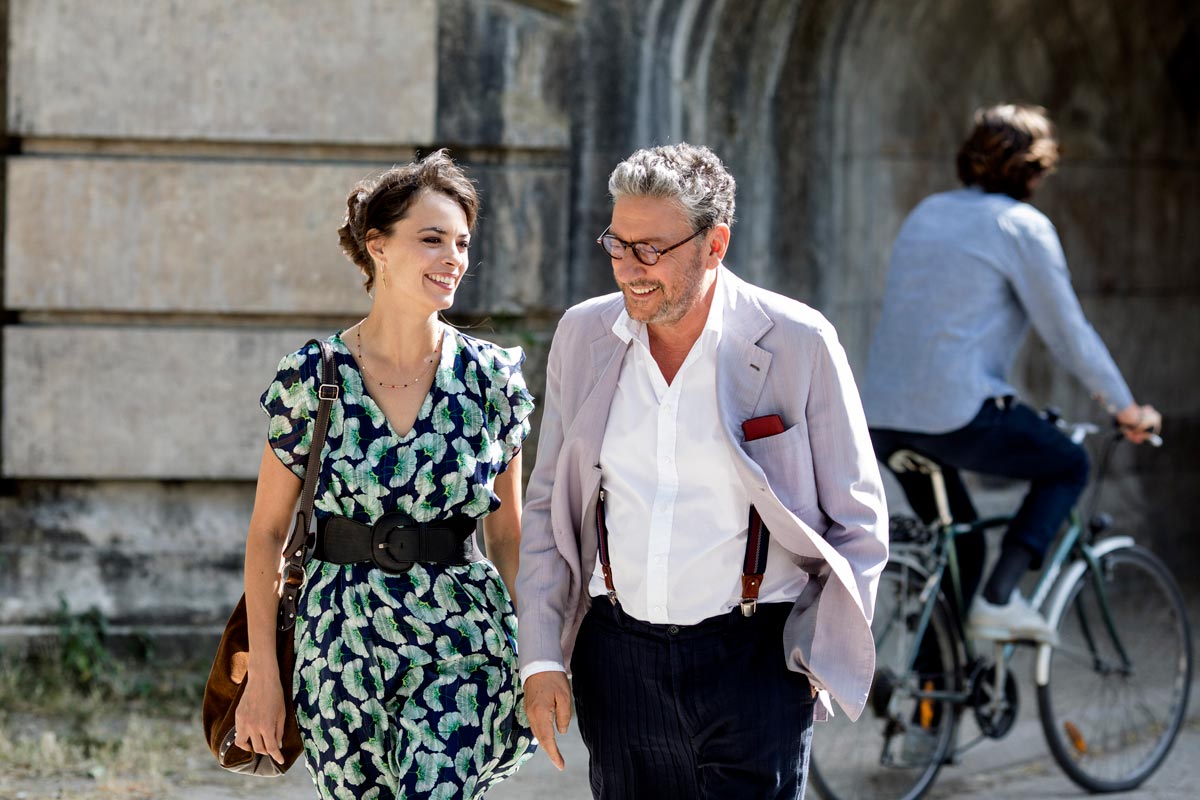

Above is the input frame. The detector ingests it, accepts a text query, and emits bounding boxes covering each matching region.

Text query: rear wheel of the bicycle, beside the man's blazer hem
[810,561,961,800]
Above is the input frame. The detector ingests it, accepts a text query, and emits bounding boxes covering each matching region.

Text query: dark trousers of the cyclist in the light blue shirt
[871,398,1090,612]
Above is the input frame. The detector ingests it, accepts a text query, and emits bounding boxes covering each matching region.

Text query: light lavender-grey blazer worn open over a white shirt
[516,266,888,718]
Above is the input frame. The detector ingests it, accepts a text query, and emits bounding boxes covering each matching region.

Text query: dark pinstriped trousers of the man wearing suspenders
[571,597,812,800]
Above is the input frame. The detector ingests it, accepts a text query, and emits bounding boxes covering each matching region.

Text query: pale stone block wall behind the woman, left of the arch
[0,0,576,632]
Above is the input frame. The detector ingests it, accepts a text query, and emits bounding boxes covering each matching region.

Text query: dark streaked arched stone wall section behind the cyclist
[571,0,1200,575]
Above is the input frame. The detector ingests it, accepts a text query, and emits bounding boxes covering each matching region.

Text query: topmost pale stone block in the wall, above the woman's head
[8,0,438,144]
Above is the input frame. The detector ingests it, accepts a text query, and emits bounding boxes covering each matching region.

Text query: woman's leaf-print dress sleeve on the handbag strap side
[259,345,320,481]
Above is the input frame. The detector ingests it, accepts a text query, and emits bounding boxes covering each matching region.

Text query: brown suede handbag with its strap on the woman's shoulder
[203,339,340,777]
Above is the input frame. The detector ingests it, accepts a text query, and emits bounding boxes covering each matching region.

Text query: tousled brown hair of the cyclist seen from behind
[958,104,1058,200]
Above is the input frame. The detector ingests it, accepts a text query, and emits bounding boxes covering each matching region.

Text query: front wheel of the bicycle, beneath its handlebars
[1038,546,1192,792]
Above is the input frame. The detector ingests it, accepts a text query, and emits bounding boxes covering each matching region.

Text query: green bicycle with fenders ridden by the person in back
[811,421,1193,800]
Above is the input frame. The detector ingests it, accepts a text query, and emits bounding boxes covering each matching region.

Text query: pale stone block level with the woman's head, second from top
[5,157,374,314]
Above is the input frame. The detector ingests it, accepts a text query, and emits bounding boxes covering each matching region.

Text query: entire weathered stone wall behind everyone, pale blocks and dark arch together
[0,0,1200,632]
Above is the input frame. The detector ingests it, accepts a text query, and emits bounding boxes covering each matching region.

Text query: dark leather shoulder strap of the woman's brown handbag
[278,339,342,631]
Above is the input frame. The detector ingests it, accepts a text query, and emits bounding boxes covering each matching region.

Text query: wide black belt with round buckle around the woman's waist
[312,511,479,572]
